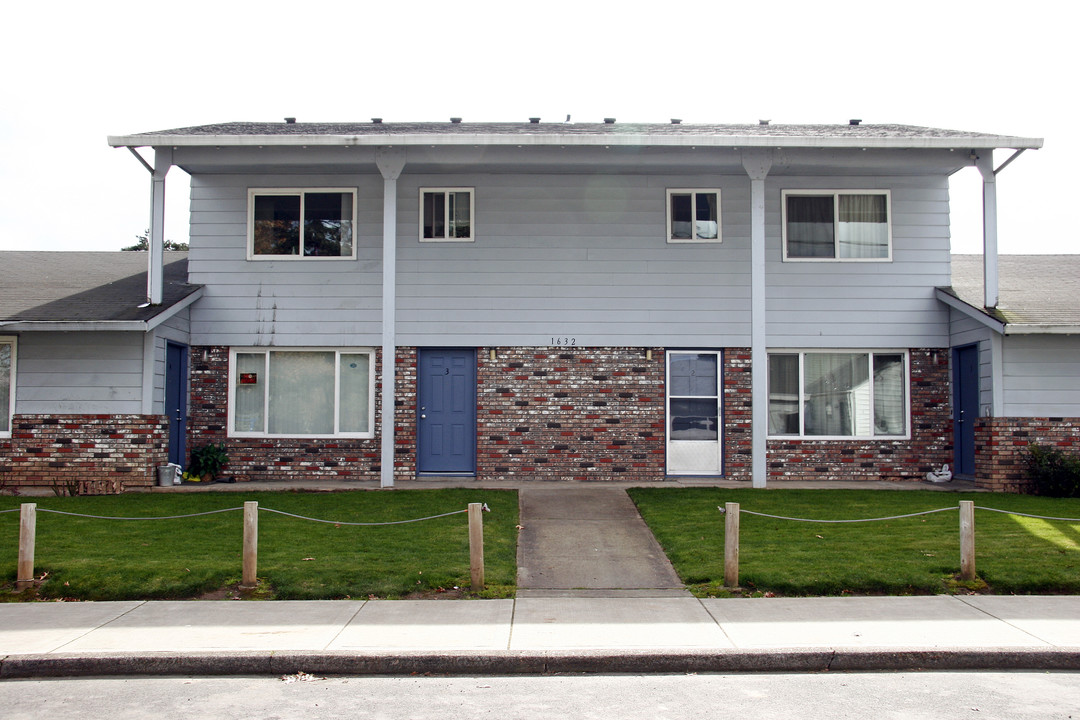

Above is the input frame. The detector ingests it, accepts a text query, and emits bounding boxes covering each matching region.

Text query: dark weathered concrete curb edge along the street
[0,648,1080,679]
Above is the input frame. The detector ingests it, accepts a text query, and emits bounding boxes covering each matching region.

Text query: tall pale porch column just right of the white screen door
[742,150,772,488]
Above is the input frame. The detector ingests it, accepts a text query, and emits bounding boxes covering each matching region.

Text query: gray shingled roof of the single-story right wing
[951,255,1080,330]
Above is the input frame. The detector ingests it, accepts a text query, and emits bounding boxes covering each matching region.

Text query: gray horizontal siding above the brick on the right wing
[1003,335,1080,418]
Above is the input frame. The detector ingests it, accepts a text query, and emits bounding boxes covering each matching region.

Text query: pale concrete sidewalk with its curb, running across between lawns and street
[0,596,1080,678]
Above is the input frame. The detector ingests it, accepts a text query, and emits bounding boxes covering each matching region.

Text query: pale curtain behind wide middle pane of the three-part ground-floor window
[268,352,334,435]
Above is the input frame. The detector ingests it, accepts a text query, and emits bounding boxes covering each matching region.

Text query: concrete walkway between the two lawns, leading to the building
[517,486,689,598]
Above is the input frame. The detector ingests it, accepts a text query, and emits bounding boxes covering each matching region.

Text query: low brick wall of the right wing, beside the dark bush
[975,418,1080,492]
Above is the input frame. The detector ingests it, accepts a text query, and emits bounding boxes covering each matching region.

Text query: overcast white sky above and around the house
[0,0,1080,253]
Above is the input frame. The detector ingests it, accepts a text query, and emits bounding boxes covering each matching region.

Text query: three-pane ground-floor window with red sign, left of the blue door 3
[229,348,375,437]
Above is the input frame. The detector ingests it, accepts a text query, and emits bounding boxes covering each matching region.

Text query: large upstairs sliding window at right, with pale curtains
[783,190,892,260]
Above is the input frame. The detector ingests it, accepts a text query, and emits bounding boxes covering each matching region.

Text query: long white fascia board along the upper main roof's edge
[109,133,1042,149]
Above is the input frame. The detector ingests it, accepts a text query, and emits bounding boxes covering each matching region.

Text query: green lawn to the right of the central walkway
[630,488,1080,596]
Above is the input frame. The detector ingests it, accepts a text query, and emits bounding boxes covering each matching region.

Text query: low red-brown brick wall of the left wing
[0,415,168,494]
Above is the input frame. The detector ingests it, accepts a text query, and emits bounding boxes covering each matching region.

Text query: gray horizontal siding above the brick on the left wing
[15,332,143,415]
